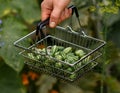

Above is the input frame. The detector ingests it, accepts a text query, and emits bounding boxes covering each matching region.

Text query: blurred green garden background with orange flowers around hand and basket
[0,0,120,93]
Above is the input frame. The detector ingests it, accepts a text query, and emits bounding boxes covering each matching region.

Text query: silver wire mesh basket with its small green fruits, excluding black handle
[14,5,105,82]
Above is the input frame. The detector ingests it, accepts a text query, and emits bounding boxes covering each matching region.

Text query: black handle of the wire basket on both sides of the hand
[36,5,81,37]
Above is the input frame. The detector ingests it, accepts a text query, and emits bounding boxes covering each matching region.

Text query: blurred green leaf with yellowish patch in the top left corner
[0,0,40,23]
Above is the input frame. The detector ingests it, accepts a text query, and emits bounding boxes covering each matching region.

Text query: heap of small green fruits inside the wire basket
[28,45,89,74]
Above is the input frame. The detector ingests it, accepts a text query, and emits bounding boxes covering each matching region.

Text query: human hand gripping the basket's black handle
[41,0,72,28]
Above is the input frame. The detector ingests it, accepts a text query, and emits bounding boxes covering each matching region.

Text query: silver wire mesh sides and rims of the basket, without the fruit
[14,26,105,82]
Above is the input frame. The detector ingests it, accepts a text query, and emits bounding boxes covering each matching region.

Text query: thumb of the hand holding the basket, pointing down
[50,8,62,28]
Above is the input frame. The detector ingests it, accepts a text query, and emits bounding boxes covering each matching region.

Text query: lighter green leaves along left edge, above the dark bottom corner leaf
[0,0,40,72]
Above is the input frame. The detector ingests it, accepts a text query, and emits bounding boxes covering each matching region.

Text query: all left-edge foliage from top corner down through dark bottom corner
[0,0,40,93]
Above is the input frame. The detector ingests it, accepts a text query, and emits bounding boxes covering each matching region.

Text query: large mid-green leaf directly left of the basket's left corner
[0,15,27,72]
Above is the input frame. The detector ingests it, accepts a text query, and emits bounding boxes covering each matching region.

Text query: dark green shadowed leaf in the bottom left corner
[0,61,26,93]
